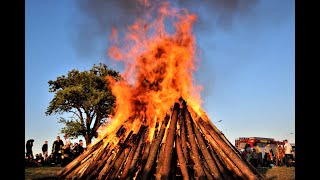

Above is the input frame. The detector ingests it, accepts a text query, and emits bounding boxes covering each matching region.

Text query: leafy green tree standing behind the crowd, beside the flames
[45,63,121,145]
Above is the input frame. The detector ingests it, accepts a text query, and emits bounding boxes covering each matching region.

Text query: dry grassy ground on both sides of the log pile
[25,167,295,180]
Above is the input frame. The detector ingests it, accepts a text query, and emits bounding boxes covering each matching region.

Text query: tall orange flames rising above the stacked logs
[96,0,201,141]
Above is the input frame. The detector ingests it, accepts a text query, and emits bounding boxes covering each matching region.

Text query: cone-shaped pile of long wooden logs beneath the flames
[56,101,261,180]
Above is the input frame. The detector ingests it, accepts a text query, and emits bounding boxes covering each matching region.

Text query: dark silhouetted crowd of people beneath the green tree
[25,136,86,167]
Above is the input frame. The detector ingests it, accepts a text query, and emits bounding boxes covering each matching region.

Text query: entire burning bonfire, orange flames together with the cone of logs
[57,1,261,179]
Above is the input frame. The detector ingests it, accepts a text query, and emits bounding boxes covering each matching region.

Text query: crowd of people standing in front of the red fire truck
[242,140,295,167]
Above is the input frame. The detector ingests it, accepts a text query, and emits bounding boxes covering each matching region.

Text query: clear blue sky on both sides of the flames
[25,0,295,154]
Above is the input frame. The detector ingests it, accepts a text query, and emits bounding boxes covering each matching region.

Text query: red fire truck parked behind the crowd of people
[235,137,284,152]
